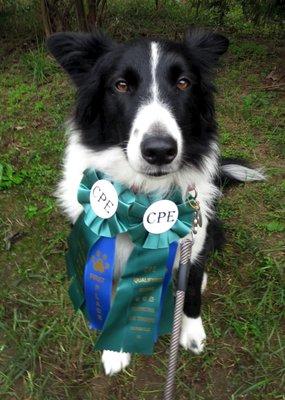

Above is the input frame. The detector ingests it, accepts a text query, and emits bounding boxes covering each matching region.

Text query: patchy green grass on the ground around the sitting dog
[0,3,285,400]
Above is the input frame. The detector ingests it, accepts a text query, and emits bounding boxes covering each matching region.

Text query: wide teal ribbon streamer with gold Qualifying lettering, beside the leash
[95,246,171,354]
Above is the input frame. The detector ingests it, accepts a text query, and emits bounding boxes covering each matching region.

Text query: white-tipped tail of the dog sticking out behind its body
[217,158,266,187]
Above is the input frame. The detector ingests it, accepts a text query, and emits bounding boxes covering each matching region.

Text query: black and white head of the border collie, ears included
[48,29,228,180]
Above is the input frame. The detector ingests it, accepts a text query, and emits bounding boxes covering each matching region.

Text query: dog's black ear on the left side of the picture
[47,32,114,86]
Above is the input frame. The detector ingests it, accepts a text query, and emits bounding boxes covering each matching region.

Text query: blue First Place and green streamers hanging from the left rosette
[66,213,116,329]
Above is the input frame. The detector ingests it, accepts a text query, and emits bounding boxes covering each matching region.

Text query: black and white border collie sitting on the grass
[48,29,264,375]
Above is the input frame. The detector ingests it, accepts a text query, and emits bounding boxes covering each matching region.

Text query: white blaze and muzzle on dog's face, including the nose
[127,42,182,176]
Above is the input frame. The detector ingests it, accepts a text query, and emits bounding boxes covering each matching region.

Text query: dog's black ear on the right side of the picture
[184,28,229,69]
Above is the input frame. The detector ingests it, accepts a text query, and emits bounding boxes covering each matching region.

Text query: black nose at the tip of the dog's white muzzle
[141,136,177,165]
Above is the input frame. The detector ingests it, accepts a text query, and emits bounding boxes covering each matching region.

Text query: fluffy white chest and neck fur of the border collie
[57,129,218,278]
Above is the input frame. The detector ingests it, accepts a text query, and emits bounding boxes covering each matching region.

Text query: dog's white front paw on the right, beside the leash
[180,314,206,354]
